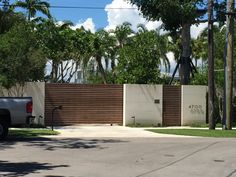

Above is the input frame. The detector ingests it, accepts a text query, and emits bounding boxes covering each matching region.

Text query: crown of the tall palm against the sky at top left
[14,0,51,21]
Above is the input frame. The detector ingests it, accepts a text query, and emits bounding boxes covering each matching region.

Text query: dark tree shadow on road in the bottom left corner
[0,160,69,177]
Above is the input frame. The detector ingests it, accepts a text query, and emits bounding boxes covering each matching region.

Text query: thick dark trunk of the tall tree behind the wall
[179,23,191,85]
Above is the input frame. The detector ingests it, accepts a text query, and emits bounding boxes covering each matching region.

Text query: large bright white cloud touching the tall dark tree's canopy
[105,0,162,31]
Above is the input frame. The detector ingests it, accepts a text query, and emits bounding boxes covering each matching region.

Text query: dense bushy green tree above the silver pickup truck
[0,23,46,89]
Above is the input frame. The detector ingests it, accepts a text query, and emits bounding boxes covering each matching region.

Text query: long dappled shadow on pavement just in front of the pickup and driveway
[0,137,128,151]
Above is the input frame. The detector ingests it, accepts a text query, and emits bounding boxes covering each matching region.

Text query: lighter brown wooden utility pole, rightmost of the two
[224,0,234,130]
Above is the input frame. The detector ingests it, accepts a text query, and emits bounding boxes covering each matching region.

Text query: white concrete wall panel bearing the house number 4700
[181,85,207,125]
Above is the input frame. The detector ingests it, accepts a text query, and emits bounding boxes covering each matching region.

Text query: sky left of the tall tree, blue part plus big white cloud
[10,0,166,31]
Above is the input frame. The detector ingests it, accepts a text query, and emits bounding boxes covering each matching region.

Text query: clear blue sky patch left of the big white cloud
[48,0,112,29]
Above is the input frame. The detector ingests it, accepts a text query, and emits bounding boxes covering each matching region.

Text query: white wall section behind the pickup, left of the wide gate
[0,82,45,125]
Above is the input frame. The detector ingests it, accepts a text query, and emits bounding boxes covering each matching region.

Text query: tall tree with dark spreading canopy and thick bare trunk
[129,0,205,84]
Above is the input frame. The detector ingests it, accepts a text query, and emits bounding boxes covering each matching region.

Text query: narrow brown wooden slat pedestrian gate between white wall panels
[163,85,181,126]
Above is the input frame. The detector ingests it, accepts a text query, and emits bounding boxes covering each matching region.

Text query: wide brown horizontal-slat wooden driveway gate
[45,84,123,125]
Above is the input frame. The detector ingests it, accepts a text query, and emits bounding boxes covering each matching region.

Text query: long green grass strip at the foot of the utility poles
[148,129,236,138]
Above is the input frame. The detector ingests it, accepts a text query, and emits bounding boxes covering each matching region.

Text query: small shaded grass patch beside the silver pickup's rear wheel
[8,128,59,138]
